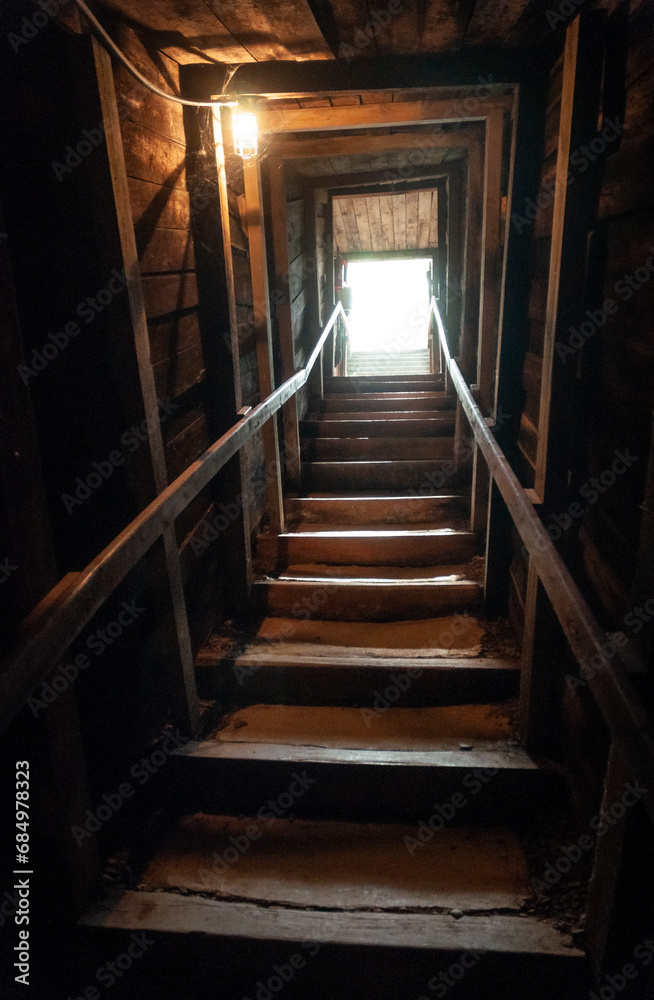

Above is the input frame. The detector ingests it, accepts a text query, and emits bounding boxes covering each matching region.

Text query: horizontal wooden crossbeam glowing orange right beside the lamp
[258,94,513,134]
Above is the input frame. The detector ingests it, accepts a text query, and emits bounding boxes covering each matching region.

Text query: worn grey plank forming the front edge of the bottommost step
[81,889,583,961]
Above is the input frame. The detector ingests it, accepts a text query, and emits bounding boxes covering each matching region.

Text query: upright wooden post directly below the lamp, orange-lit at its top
[243,157,284,534]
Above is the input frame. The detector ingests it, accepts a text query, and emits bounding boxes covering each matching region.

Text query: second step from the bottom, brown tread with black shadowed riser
[167,720,564,829]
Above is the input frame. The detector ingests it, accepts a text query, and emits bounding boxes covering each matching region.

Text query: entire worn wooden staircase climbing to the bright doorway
[80,375,583,1000]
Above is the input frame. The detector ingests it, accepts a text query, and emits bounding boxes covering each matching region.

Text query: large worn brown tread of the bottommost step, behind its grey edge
[135,812,531,912]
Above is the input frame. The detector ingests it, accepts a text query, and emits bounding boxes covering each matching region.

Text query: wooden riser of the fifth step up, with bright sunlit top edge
[257,528,476,571]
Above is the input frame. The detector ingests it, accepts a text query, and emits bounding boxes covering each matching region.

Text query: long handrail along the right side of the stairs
[430,298,654,817]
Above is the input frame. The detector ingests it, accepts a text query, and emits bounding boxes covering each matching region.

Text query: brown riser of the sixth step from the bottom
[284,493,466,525]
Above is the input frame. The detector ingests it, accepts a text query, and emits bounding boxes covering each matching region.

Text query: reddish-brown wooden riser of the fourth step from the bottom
[252,570,481,621]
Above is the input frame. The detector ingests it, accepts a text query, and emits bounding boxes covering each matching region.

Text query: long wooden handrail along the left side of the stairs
[0,302,346,732]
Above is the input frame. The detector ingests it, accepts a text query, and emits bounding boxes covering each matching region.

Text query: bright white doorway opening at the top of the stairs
[346,257,433,375]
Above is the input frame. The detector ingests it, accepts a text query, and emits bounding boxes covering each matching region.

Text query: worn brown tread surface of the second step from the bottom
[212,704,515,751]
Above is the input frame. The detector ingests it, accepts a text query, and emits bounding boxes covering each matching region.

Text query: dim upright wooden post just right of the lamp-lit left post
[268,157,302,492]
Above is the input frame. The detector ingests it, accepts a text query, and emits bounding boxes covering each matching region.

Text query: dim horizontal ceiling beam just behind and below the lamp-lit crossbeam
[269,128,483,160]
